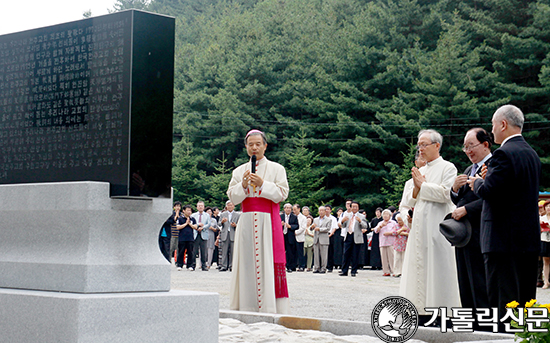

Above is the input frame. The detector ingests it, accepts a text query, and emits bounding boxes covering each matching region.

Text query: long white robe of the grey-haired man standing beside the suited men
[399,157,460,314]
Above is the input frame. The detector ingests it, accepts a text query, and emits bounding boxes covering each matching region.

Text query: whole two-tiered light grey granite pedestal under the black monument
[0,182,218,343]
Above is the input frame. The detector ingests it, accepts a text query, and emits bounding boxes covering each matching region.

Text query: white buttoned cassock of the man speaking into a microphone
[227,157,289,314]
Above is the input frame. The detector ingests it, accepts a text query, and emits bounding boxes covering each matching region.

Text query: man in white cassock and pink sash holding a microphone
[227,130,289,314]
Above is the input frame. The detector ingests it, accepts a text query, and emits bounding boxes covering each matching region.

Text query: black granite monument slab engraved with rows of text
[0,10,175,197]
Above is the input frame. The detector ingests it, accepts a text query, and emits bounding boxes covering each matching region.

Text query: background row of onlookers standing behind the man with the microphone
[159,199,412,277]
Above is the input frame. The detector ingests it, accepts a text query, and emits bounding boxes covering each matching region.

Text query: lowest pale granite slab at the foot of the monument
[0,288,219,343]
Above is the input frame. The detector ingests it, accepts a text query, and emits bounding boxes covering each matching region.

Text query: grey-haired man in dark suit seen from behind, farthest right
[468,105,541,331]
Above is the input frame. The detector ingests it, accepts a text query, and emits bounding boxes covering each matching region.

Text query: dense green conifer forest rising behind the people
[114,0,550,214]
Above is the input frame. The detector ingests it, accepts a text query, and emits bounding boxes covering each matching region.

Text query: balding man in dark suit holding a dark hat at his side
[451,128,492,322]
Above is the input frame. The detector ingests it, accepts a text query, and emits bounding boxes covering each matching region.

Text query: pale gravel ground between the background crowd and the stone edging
[171,266,550,322]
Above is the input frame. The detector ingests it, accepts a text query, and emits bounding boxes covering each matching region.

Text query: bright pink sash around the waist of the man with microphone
[241,197,288,298]
